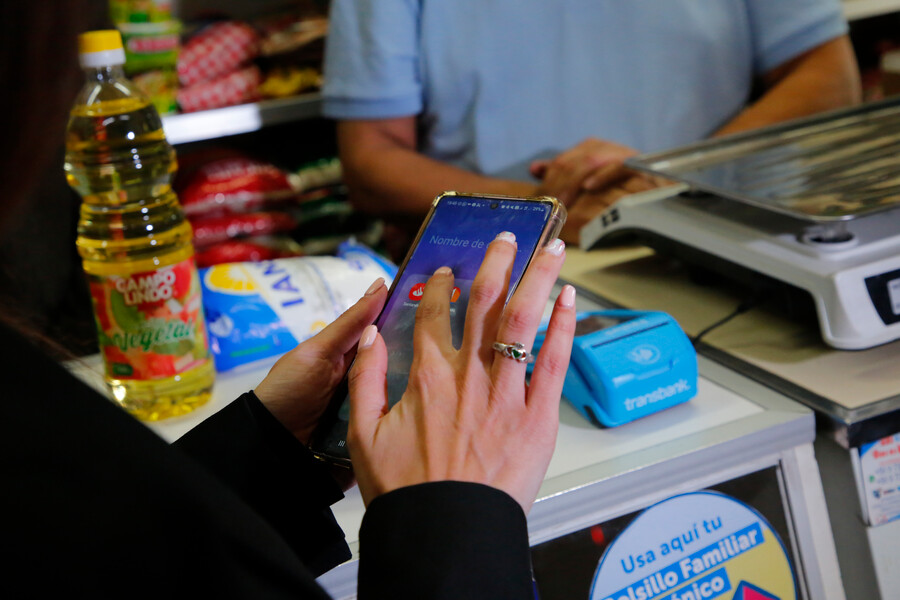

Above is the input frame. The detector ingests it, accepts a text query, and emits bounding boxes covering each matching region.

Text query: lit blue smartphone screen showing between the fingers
[376,196,551,406]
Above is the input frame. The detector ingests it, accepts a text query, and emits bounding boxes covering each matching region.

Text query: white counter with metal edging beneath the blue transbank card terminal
[65,284,844,600]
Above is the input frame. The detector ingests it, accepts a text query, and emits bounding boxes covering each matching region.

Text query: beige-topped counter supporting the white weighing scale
[561,247,900,599]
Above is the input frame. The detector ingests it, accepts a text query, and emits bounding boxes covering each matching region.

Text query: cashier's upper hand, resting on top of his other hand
[530,138,654,207]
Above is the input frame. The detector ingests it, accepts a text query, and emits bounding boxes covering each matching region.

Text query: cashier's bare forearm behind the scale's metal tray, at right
[716,36,862,135]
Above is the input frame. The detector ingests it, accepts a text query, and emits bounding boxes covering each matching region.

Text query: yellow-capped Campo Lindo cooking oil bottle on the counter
[65,30,215,421]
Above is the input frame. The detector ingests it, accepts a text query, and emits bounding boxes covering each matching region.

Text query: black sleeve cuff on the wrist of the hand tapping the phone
[358,481,535,600]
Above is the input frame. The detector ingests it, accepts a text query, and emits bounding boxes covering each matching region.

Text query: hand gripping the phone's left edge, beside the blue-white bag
[254,279,387,444]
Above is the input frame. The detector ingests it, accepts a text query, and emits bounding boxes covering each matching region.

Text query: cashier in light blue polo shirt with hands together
[324,0,860,240]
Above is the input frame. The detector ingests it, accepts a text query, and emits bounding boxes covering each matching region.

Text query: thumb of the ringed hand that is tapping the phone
[348,325,388,440]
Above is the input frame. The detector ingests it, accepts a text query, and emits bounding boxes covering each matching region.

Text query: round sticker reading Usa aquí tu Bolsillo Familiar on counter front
[590,492,797,600]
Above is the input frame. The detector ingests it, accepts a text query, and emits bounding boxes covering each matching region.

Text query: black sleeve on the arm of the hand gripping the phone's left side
[174,392,350,576]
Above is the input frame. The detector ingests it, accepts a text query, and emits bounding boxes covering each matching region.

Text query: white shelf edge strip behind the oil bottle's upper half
[163,94,322,144]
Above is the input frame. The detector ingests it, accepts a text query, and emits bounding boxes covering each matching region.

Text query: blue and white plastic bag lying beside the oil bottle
[200,241,397,371]
